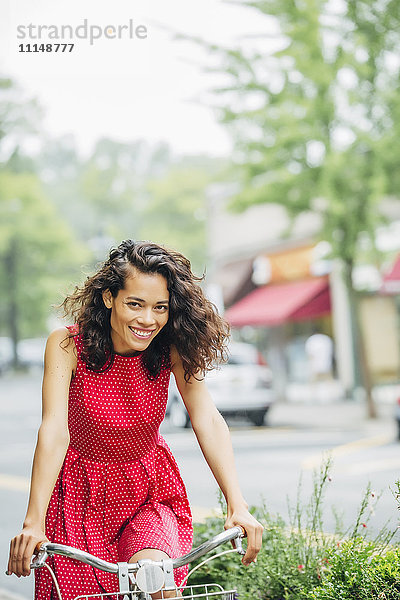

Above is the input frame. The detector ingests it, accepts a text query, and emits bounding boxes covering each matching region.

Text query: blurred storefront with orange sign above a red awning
[225,244,335,398]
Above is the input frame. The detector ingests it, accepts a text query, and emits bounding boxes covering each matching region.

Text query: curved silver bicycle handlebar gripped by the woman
[31,526,243,574]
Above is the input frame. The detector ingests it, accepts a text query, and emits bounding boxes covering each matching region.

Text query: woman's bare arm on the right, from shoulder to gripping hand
[171,348,263,565]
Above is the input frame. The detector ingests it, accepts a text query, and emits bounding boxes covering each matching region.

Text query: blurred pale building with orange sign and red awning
[208,186,400,397]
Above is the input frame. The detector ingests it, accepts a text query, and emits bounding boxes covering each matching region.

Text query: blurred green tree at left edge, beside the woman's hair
[0,171,89,365]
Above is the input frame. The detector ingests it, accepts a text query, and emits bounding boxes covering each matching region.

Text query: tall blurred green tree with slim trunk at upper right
[191,0,400,416]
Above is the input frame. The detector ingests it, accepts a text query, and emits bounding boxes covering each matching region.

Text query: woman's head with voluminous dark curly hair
[57,240,229,381]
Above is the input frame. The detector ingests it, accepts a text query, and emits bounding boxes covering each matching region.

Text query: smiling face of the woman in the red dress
[103,268,169,356]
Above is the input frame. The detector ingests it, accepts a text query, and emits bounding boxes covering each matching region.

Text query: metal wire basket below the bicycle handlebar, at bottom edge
[75,583,237,600]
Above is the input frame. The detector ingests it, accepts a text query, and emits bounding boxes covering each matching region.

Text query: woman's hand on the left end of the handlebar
[7,527,49,577]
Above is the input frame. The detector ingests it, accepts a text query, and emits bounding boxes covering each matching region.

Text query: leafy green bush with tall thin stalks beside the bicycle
[190,461,400,600]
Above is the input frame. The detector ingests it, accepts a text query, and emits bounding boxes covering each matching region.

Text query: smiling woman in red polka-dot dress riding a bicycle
[8,240,262,600]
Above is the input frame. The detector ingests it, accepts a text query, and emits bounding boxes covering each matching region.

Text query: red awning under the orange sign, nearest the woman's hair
[225,277,331,327]
